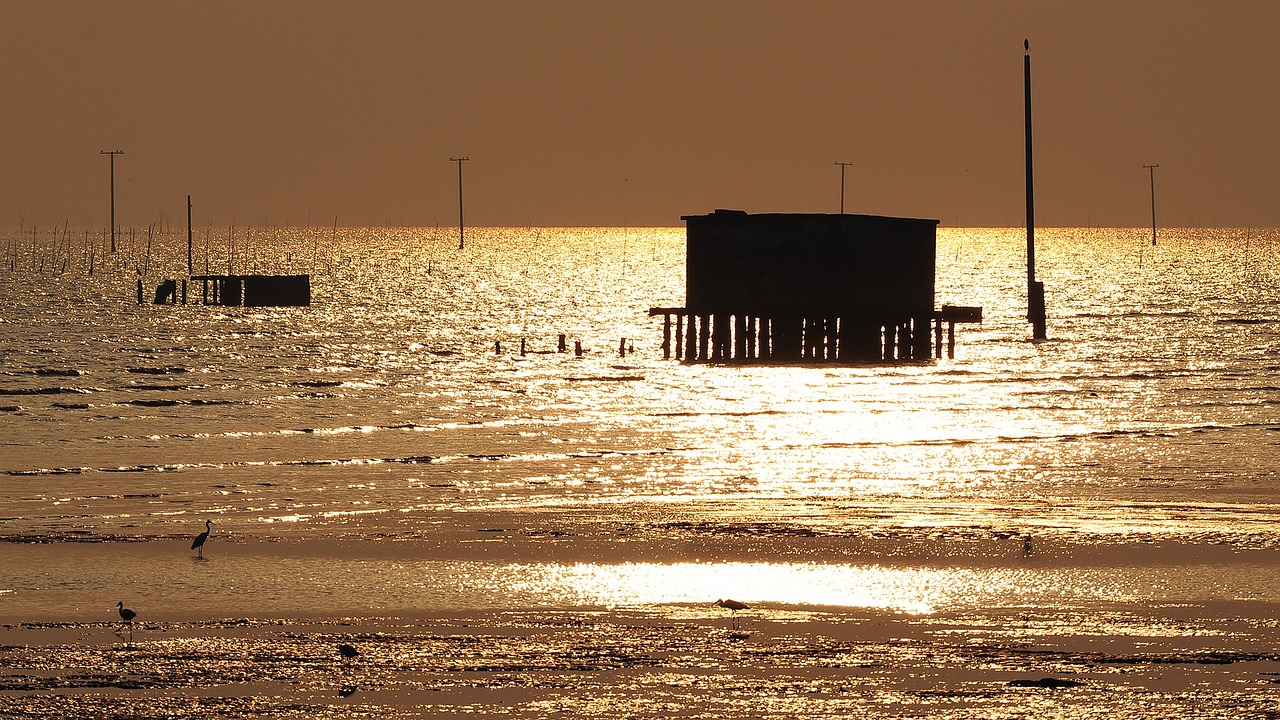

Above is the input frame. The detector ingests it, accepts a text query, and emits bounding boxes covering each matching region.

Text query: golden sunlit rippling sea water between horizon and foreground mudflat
[0,228,1280,619]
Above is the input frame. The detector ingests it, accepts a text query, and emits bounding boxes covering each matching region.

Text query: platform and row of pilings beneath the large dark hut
[649,306,982,363]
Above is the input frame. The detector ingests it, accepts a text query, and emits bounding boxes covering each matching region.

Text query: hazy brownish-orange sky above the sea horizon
[0,0,1280,228]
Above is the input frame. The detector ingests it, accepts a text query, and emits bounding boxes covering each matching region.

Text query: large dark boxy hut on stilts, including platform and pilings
[649,210,982,363]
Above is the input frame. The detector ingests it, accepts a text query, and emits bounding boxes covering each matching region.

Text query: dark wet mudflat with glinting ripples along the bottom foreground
[0,603,1280,717]
